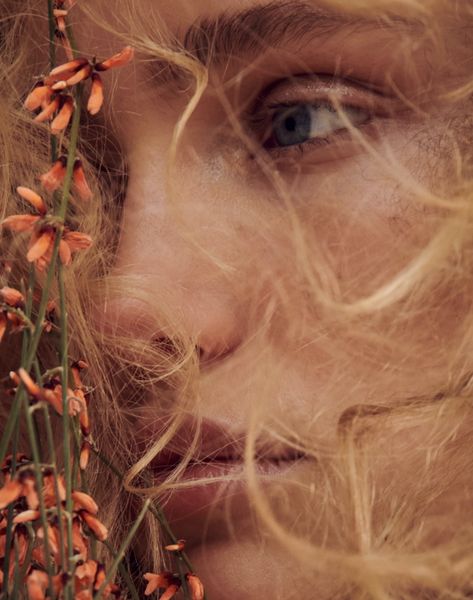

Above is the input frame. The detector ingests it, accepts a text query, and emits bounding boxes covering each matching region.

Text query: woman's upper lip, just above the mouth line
[139,418,305,471]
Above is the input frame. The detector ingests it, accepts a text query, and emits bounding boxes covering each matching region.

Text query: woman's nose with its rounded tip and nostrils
[101,198,248,366]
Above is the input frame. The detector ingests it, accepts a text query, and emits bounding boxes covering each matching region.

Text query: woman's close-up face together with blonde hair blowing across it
[0,0,473,600]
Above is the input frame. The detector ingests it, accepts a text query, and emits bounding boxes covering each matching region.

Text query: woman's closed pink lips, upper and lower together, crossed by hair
[141,419,307,522]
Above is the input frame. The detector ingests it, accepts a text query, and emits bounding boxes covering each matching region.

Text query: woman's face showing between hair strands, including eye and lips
[84,0,467,600]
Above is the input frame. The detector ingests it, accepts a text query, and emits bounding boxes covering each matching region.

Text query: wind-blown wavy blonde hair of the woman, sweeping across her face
[0,0,473,600]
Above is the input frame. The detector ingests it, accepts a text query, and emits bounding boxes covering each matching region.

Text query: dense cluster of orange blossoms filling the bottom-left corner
[0,454,115,600]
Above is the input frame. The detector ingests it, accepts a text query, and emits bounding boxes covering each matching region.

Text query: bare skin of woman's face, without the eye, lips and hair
[74,0,468,600]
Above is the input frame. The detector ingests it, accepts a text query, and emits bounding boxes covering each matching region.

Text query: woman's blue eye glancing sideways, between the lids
[269,103,370,147]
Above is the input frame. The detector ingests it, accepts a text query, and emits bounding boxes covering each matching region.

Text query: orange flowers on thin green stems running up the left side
[0,0,205,600]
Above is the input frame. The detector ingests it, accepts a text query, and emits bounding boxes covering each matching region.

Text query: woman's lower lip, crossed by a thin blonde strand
[155,458,306,522]
